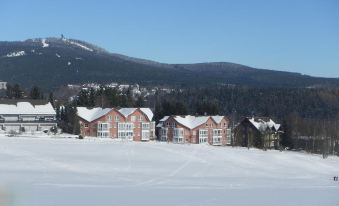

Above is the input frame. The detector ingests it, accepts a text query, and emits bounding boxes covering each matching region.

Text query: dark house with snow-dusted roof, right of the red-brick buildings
[234,118,282,149]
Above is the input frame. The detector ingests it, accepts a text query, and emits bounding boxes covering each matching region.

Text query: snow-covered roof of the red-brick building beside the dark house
[174,115,223,129]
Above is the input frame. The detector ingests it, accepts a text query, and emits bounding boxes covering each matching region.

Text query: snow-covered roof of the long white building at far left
[0,101,56,115]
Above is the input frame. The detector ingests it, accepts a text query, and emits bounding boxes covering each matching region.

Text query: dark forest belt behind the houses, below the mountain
[2,85,339,153]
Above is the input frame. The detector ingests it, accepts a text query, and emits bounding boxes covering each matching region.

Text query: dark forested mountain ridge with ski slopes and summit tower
[0,37,339,89]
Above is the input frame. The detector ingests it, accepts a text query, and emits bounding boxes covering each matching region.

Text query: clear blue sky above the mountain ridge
[0,0,339,77]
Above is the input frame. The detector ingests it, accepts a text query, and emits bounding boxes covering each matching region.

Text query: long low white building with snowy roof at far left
[0,100,57,133]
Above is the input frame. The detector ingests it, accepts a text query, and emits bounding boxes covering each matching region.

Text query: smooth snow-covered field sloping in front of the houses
[0,137,339,206]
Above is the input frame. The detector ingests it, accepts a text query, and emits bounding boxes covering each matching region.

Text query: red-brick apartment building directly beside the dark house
[157,115,230,145]
